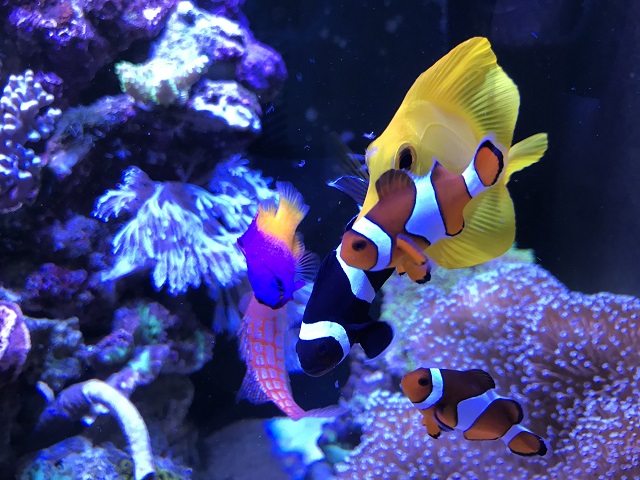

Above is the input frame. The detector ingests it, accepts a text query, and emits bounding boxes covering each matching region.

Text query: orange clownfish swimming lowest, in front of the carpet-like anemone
[400,368,547,456]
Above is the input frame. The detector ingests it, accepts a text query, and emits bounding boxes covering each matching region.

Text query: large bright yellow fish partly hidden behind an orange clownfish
[358,37,547,268]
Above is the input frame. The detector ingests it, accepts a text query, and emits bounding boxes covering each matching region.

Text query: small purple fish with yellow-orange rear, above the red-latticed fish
[238,182,318,309]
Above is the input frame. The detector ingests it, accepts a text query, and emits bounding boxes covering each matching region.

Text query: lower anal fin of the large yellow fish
[425,183,516,269]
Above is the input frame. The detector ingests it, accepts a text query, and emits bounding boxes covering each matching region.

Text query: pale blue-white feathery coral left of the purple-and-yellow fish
[93,159,268,295]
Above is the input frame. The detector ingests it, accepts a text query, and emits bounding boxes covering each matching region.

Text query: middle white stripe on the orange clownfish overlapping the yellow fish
[405,164,447,245]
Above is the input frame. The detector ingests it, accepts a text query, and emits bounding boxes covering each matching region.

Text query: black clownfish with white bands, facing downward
[296,245,393,377]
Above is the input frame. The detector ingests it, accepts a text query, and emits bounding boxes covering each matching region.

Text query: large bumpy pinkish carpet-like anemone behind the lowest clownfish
[338,263,640,479]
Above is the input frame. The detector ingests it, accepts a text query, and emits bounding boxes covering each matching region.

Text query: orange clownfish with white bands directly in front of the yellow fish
[341,139,504,283]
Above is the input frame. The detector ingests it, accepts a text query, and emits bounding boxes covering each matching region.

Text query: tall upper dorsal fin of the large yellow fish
[404,37,520,146]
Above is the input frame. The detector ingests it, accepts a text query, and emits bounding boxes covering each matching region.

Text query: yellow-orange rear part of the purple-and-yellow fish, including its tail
[257,182,309,249]
